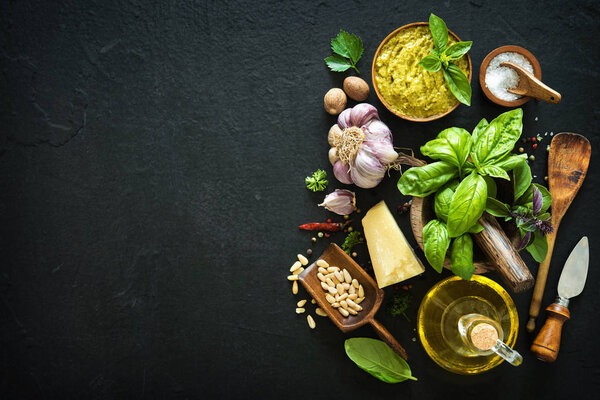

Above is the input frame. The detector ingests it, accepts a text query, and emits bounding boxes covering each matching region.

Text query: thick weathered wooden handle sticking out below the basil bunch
[474,213,534,293]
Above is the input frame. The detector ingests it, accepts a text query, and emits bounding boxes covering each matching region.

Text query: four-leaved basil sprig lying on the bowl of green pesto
[419,14,473,106]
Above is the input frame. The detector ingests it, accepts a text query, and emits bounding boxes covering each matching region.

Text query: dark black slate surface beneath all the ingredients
[0,0,600,399]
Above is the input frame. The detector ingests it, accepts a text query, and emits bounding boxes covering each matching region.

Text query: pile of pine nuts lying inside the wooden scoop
[317,260,365,318]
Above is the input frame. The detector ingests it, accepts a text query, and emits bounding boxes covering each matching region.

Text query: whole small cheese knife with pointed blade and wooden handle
[531,236,590,362]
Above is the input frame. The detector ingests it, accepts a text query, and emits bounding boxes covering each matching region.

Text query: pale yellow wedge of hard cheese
[362,201,425,288]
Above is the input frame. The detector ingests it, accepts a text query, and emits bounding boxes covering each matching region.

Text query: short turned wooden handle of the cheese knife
[531,303,571,362]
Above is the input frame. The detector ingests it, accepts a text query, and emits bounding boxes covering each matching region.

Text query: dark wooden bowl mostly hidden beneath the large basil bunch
[410,196,521,274]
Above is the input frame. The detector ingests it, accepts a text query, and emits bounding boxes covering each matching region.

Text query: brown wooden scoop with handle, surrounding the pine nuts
[298,243,408,360]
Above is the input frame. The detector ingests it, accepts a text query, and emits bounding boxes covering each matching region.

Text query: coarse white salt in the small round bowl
[485,51,533,101]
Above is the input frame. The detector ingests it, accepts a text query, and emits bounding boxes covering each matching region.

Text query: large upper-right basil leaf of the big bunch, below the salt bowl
[473,108,523,165]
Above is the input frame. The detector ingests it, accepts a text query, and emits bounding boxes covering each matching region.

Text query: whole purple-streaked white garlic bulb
[328,103,398,189]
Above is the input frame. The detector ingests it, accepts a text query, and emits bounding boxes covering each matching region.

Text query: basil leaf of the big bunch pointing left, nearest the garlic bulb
[398,161,458,197]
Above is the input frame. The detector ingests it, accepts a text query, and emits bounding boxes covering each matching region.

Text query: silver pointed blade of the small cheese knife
[558,236,590,299]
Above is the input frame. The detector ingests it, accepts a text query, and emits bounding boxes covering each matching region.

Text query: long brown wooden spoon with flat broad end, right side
[527,133,592,332]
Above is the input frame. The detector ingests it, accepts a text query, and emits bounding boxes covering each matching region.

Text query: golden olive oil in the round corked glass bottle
[417,275,519,374]
